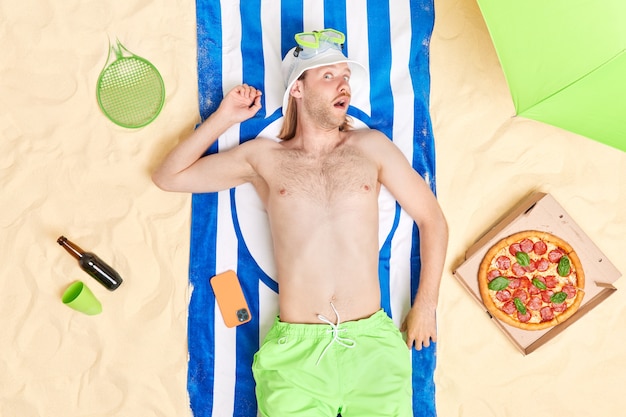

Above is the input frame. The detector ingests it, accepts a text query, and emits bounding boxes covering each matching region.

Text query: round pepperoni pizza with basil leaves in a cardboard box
[478,230,585,330]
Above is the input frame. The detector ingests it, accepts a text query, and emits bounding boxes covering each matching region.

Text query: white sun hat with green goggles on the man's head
[281,29,367,115]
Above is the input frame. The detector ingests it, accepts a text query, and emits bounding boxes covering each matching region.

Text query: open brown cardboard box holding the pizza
[454,192,621,355]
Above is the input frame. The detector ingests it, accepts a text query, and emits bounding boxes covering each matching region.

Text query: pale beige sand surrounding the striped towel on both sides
[0,0,626,417]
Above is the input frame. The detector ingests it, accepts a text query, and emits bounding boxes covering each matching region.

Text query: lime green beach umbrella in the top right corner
[477,0,626,151]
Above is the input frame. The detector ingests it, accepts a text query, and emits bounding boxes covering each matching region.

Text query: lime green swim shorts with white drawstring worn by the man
[252,310,413,417]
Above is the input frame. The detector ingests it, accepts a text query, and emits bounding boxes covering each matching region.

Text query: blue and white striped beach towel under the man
[187,0,436,417]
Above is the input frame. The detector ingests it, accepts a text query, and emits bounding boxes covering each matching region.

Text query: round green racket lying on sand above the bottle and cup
[96,40,165,128]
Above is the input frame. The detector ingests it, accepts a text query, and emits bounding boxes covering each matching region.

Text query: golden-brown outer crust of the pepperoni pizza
[478,230,585,330]
